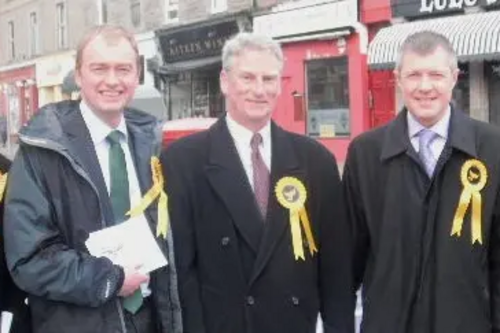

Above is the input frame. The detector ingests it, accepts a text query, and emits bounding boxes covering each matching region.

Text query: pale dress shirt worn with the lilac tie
[407,107,451,161]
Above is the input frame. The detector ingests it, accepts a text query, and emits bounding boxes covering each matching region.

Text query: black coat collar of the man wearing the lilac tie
[380,106,477,160]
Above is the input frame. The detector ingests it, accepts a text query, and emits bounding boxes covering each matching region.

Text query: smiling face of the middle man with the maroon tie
[220,48,281,132]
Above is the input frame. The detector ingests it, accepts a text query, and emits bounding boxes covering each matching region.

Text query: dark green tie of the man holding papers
[106,130,143,313]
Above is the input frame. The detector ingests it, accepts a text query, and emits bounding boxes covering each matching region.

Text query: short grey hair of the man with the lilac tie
[396,30,458,71]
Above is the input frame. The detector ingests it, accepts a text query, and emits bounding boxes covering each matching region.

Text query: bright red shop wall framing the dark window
[273,34,370,163]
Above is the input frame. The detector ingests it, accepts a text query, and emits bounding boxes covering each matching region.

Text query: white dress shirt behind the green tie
[80,100,151,297]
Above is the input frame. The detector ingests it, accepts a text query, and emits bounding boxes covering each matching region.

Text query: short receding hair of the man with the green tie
[75,24,142,72]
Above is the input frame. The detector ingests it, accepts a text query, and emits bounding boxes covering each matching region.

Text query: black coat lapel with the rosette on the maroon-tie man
[250,123,307,283]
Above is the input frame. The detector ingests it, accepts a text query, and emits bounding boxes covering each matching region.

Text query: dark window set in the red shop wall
[306,57,351,138]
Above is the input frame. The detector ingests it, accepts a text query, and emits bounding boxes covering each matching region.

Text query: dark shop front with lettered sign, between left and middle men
[155,13,250,120]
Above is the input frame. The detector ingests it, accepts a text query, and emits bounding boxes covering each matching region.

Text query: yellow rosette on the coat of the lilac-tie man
[451,159,488,244]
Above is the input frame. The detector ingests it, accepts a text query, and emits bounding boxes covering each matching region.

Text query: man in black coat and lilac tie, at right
[344,31,500,333]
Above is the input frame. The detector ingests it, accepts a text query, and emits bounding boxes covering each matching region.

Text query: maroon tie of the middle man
[250,133,269,221]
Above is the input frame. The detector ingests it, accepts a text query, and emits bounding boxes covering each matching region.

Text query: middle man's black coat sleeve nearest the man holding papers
[161,149,205,333]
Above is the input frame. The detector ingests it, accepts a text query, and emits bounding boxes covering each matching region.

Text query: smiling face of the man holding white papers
[75,36,139,123]
